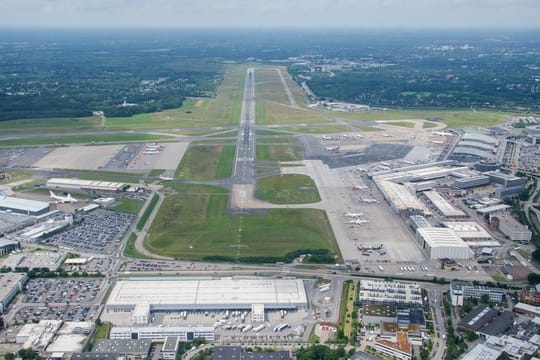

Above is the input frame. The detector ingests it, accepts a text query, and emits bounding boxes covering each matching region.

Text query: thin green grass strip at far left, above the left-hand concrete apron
[0,132,173,146]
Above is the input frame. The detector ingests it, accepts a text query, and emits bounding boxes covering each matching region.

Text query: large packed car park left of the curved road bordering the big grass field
[42,209,135,254]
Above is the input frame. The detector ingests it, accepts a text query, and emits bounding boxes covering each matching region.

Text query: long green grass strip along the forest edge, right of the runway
[317,110,512,128]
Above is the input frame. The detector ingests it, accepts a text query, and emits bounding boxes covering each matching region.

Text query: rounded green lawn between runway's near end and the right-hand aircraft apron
[255,174,321,204]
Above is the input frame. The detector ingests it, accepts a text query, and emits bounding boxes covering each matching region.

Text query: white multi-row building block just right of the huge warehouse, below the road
[358,280,422,305]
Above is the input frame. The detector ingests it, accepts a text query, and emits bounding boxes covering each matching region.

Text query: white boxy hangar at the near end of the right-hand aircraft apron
[416,228,473,260]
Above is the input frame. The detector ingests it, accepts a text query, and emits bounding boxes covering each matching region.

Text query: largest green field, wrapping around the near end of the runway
[145,184,338,260]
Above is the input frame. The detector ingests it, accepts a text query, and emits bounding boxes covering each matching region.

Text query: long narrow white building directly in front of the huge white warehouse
[109,326,215,342]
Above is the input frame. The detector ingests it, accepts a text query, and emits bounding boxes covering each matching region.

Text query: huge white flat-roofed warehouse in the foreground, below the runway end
[106,278,308,324]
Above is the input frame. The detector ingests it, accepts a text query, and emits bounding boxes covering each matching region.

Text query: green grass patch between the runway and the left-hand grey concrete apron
[176,145,235,180]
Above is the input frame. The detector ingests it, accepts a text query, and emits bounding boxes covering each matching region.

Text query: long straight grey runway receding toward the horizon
[232,68,256,184]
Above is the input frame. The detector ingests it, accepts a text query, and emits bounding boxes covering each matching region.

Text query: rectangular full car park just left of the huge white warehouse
[21,278,103,304]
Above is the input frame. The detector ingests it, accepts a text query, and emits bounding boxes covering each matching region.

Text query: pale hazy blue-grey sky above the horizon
[0,0,540,29]
